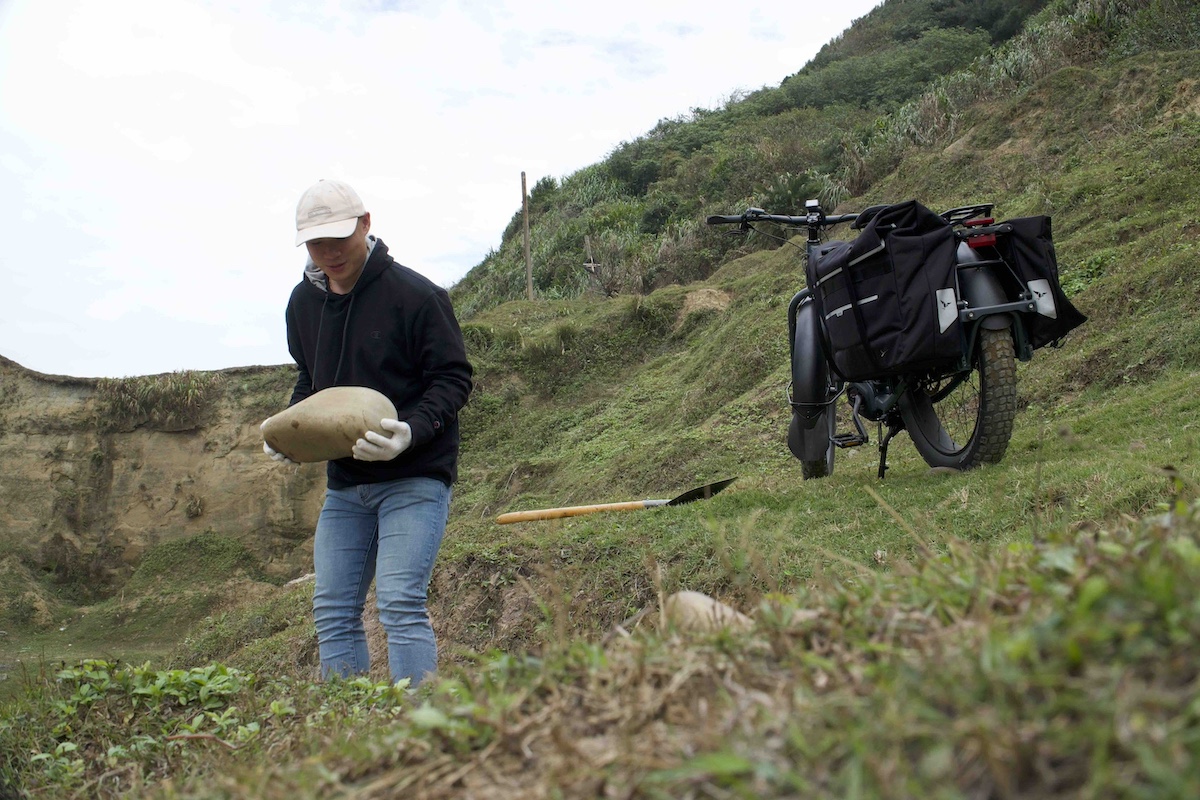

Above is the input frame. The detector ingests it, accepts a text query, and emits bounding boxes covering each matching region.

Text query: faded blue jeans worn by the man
[312,477,450,686]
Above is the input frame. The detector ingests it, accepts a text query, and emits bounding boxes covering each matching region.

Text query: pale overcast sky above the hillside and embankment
[0,0,881,377]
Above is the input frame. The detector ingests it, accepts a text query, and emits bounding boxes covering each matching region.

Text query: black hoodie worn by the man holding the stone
[287,237,472,488]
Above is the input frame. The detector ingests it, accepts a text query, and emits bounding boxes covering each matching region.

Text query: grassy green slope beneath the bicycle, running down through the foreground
[0,2,1200,798]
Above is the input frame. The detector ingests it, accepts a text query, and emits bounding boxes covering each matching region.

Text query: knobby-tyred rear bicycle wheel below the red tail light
[900,329,1016,470]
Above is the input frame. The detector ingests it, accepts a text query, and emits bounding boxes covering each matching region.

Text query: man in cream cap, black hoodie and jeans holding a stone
[263,180,472,685]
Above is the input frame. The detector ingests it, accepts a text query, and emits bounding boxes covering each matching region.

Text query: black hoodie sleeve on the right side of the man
[407,290,473,445]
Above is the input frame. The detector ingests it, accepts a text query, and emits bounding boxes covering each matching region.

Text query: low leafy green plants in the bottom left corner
[0,658,427,798]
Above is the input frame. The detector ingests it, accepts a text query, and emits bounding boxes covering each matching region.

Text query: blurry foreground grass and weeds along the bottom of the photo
[0,496,1200,798]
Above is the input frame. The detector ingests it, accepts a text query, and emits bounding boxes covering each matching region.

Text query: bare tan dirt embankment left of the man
[0,357,324,599]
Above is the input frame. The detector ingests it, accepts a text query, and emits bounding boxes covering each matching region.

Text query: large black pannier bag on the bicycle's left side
[808,200,962,380]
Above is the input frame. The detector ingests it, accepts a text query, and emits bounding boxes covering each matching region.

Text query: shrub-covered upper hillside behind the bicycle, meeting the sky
[454,0,1200,317]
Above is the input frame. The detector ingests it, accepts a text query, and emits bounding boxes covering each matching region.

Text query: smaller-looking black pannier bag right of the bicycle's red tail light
[996,217,1087,349]
